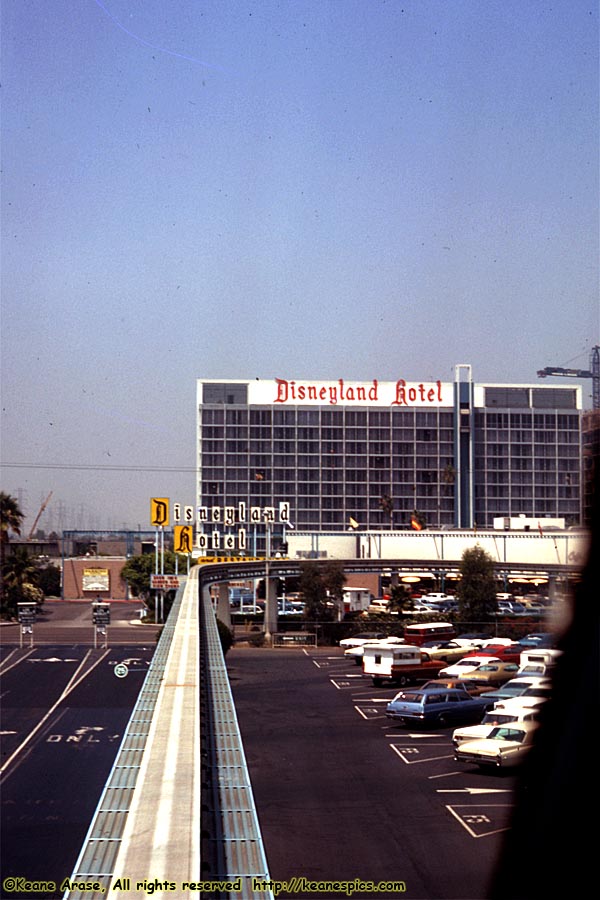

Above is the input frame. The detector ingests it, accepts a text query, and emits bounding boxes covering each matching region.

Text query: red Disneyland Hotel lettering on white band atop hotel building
[274,378,444,406]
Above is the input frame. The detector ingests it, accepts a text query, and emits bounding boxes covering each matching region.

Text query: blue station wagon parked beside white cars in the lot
[386,688,492,726]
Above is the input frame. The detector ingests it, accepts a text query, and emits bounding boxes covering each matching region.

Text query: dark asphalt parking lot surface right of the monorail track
[227,647,513,900]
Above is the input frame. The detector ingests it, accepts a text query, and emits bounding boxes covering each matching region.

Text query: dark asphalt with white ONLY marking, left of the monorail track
[0,644,154,900]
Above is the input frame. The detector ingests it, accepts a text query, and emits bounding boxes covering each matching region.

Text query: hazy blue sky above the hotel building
[1,0,600,528]
